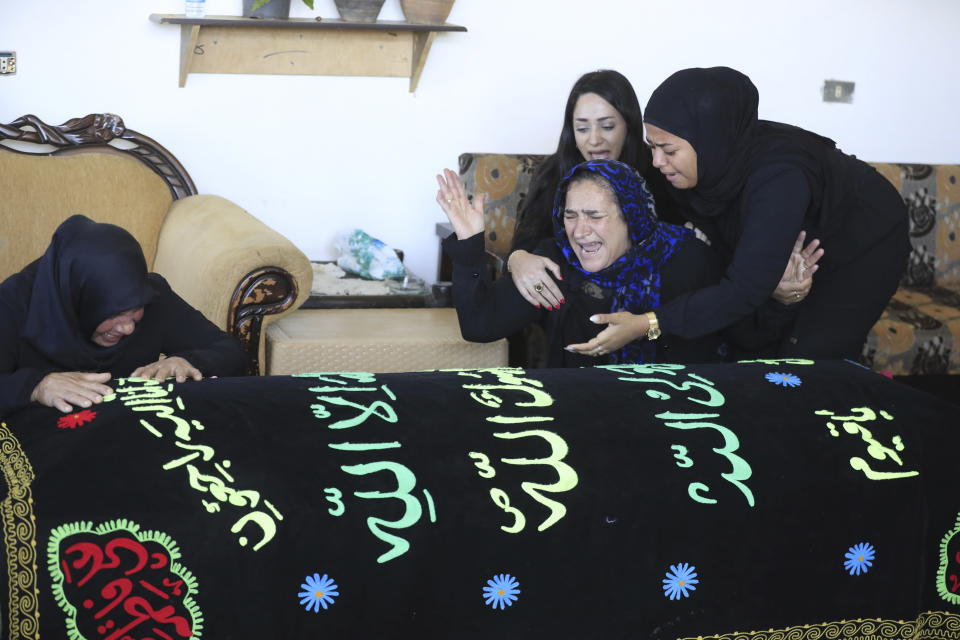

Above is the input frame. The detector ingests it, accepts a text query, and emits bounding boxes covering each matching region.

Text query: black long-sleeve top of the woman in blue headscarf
[443,233,725,367]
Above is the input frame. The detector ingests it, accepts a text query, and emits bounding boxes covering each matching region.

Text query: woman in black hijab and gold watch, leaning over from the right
[628,67,910,358]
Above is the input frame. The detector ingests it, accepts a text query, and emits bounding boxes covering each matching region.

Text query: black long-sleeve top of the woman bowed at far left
[0,274,247,416]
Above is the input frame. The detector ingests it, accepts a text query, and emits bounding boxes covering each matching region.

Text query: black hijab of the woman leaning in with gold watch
[644,67,855,231]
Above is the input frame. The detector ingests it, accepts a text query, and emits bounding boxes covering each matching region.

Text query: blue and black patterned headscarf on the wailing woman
[553,160,694,363]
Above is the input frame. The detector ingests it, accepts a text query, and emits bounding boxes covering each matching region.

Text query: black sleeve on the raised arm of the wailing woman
[443,233,542,342]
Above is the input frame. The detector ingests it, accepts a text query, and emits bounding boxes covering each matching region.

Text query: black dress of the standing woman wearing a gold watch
[657,160,910,359]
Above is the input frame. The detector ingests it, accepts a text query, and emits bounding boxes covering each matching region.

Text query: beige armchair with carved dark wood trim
[0,114,313,374]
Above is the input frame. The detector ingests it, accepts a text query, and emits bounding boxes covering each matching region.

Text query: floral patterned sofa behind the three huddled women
[460,153,960,375]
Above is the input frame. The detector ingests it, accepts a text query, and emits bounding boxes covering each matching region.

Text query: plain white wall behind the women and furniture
[0,0,960,280]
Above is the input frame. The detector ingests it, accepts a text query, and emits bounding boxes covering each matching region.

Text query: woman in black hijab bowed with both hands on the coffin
[0,215,246,416]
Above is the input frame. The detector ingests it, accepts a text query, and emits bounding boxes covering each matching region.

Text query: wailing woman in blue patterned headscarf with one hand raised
[437,160,723,367]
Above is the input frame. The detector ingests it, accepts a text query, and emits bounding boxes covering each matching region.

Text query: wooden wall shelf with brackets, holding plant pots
[150,13,467,92]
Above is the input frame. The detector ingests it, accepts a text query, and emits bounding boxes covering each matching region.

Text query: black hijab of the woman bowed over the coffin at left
[23,215,153,371]
